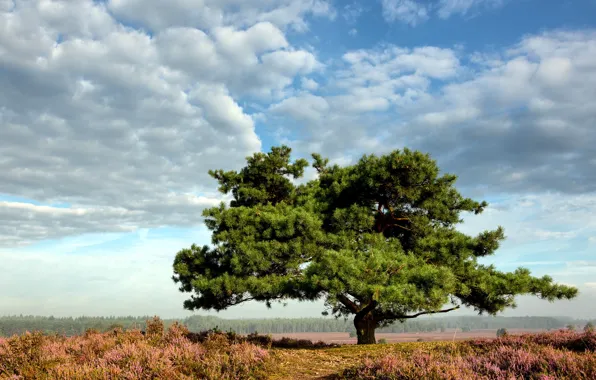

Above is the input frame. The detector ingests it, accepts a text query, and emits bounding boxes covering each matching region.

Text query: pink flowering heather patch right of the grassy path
[340,331,596,380]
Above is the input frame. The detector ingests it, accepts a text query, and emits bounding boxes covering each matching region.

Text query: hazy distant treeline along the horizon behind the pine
[0,315,596,336]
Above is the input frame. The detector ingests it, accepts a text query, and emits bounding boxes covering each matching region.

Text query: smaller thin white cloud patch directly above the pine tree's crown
[270,45,461,158]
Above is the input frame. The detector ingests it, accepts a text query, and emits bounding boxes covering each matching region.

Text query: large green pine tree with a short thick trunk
[172,146,577,344]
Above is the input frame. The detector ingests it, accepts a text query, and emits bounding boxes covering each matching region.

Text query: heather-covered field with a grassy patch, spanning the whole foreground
[0,319,596,380]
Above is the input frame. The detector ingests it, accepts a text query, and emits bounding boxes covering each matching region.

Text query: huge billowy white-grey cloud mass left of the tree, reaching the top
[0,0,324,246]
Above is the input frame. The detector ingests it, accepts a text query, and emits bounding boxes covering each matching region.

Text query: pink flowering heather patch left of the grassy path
[0,320,271,380]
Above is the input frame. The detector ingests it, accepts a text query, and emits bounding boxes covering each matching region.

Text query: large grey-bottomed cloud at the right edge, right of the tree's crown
[408,31,596,193]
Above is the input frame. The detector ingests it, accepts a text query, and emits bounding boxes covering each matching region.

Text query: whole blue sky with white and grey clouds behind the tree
[0,0,596,318]
